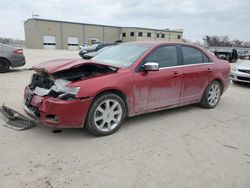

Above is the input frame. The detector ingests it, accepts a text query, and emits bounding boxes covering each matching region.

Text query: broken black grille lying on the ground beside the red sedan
[0,105,35,131]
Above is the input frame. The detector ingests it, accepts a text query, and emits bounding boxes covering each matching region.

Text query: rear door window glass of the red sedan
[181,46,204,65]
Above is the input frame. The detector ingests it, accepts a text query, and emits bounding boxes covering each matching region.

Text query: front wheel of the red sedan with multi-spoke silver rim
[85,93,126,136]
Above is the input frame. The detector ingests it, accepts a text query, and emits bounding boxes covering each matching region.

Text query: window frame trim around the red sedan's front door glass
[135,44,182,73]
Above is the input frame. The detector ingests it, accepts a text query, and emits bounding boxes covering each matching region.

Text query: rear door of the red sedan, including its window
[180,46,213,105]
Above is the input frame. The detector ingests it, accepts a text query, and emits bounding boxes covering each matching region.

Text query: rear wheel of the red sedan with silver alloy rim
[200,80,222,108]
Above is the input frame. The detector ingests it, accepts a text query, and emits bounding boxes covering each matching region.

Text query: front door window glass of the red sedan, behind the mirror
[146,46,178,68]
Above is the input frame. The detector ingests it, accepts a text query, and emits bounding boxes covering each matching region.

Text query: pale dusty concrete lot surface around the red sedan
[0,50,250,188]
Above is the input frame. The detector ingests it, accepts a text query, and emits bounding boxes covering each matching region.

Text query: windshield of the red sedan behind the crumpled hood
[93,43,152,67]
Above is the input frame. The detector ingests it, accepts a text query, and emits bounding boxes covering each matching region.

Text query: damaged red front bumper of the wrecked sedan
[24,87,93,128]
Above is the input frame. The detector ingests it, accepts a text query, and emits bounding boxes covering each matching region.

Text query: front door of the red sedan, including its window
[134,45,182,113]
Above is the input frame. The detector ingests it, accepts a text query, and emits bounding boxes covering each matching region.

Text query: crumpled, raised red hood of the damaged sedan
[33,59,119,74]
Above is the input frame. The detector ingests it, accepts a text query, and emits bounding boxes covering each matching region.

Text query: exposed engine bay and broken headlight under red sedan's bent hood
[29,64,117,100]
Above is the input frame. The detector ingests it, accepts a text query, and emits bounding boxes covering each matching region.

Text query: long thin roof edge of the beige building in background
[24,18,183,33]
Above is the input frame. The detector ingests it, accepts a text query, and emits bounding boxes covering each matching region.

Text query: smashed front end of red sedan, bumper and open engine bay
[24,64,118,128]
